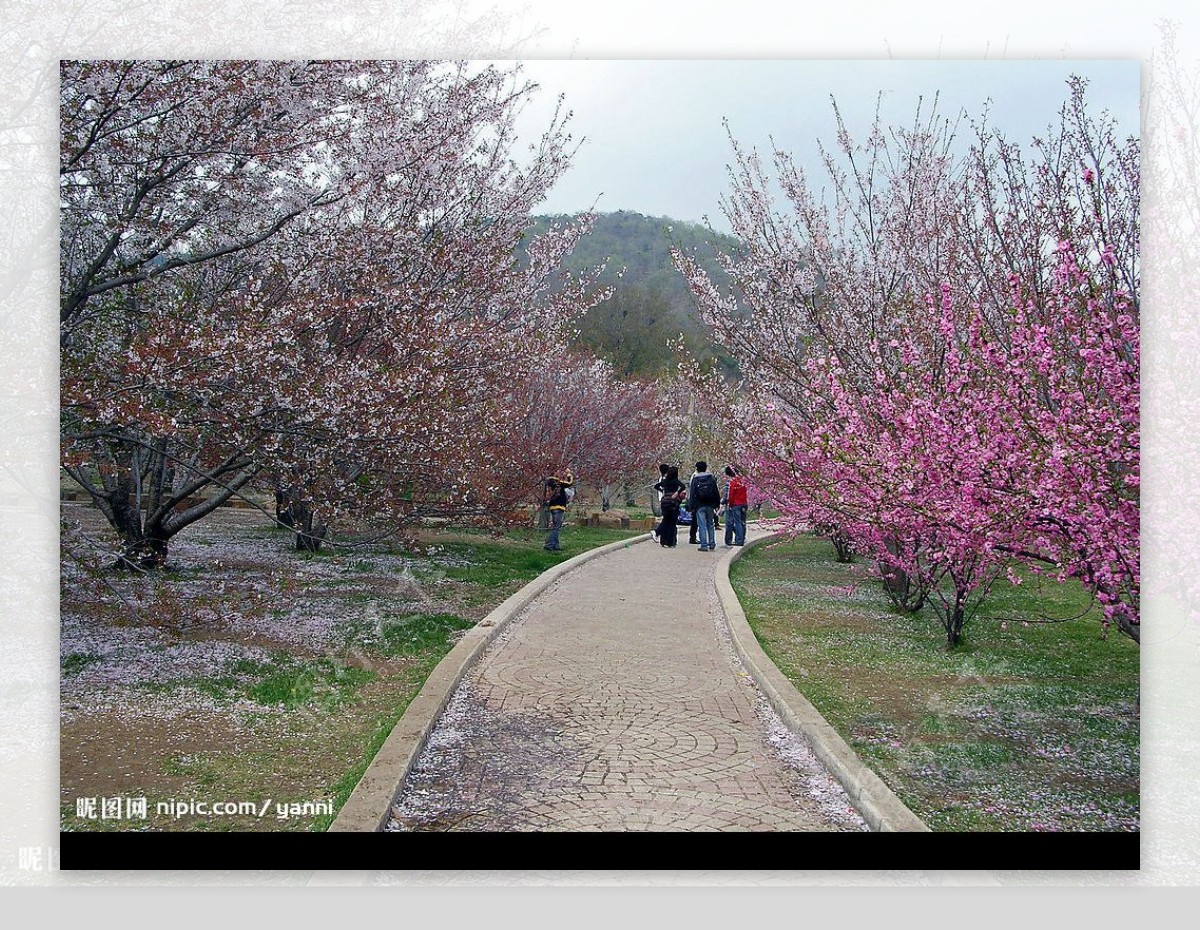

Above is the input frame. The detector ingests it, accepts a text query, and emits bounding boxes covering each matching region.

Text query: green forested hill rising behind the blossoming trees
[534,210,739,376]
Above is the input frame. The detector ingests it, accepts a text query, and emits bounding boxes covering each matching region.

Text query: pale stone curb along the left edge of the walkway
[329,533,649,833]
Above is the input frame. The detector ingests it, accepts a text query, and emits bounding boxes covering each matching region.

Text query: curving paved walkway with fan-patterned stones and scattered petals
[386,530,866,830]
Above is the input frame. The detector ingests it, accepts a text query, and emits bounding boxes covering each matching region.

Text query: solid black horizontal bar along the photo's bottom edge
[60,832,1141,871]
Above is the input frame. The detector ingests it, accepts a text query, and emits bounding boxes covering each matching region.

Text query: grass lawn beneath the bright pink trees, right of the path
[732,536,1140,830]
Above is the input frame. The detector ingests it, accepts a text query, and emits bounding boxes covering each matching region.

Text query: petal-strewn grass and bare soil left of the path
[60,504,638,830]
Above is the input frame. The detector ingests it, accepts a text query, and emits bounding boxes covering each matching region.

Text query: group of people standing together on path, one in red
[650,462,746,552]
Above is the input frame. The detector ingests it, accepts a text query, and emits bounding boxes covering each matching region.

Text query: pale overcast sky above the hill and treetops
[501,60,1139,229]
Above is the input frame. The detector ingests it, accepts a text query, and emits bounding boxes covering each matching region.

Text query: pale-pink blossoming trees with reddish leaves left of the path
[60,61,586,566]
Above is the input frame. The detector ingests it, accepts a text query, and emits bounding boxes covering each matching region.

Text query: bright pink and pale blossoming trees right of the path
[677,82,1139,646]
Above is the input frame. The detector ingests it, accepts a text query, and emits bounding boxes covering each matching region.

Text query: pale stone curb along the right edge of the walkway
[716,530,930,833]
